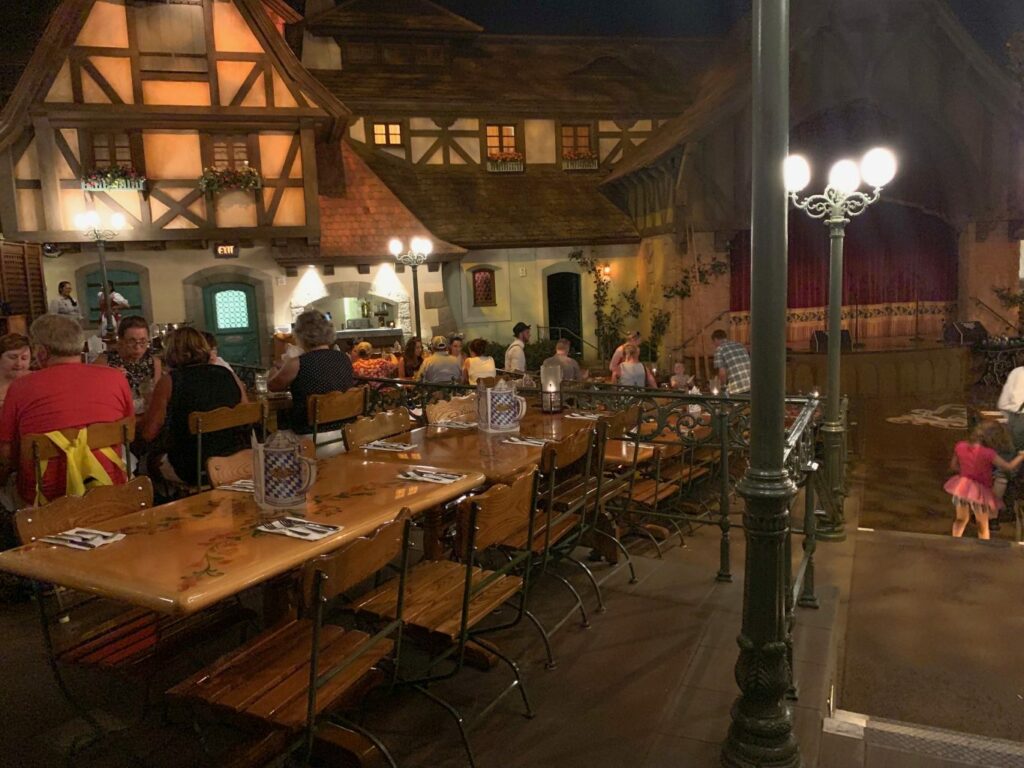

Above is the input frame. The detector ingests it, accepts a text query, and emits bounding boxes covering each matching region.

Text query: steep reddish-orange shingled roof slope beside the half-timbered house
[313,142,465,264]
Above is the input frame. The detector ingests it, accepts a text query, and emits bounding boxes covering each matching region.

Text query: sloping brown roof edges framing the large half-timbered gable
[0,0,351,147]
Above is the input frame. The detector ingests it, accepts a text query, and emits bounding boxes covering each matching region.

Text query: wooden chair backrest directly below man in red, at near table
[14,477,153,544]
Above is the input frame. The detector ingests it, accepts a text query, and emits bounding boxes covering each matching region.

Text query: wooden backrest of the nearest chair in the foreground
[302,508,412,608]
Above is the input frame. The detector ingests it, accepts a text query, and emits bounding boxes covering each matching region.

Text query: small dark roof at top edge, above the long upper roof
[306,0,483,35]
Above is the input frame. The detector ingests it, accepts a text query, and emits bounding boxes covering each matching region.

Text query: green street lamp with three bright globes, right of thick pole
[783,147,896,540]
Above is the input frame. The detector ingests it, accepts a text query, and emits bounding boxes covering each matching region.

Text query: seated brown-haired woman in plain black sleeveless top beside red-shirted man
[141,328,250,485]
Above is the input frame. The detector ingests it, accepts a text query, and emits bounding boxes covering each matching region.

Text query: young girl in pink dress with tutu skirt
[944,422,1024,539]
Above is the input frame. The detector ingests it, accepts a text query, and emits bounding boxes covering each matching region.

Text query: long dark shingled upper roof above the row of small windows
[313,36,719,119]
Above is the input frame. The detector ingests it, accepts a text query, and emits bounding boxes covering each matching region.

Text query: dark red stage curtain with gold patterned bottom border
[730,202,957,341]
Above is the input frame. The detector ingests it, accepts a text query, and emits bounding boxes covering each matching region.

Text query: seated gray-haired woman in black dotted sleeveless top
[267,309,355,434]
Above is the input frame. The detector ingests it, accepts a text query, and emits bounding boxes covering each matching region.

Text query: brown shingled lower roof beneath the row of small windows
[349,141,640,249]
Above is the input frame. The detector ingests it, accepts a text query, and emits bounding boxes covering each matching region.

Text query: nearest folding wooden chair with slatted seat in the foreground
[168,509,410,766]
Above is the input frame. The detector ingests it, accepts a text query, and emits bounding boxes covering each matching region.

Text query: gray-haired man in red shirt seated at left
[0,314,134,506]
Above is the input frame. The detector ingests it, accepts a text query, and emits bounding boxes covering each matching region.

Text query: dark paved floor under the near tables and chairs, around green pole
[0,520,838,768]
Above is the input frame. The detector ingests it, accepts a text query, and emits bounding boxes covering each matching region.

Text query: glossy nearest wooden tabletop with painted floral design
[0,456,484,613]
